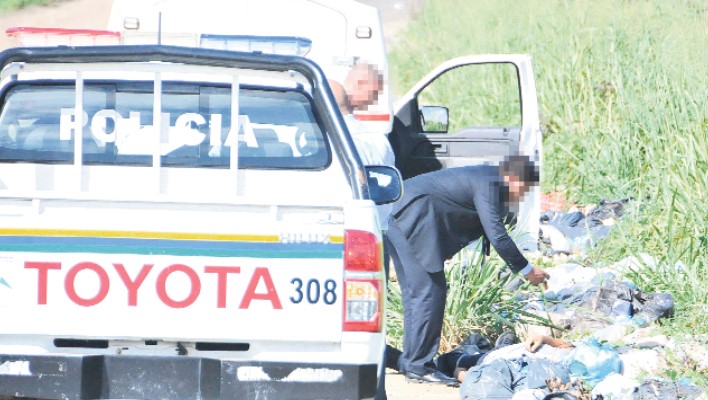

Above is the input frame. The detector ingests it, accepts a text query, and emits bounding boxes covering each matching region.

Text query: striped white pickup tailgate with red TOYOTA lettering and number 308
[0,220,343,342]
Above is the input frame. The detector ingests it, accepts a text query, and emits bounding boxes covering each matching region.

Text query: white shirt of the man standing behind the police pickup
[344,114,396,230]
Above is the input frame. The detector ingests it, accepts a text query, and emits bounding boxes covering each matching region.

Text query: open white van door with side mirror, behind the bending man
[389,54,542,251]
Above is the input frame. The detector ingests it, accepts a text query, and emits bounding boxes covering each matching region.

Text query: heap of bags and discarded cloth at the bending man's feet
[436,256,708,400]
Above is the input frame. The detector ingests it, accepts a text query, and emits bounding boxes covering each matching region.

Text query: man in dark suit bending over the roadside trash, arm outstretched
[388,156,548,386]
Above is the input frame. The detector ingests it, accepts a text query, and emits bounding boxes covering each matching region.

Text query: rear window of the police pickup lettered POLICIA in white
[0,81,330,169]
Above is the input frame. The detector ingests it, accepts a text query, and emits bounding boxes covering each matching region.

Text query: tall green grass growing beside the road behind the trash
[390,0,708,385]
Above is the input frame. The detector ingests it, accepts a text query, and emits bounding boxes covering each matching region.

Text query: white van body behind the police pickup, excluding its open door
[107,0,392,133]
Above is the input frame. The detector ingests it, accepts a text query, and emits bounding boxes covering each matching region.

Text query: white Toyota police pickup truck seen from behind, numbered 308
[0,45,401,400]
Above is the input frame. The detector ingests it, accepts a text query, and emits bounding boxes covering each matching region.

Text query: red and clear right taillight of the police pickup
[343,230,385,332]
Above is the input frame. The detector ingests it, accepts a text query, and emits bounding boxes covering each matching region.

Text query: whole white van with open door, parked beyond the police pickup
[108,0,542,251]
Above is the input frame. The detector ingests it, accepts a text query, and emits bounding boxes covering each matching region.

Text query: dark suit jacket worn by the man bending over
[389,166,528,273]
